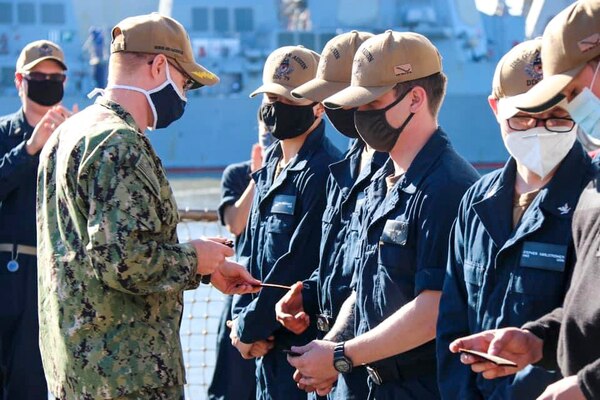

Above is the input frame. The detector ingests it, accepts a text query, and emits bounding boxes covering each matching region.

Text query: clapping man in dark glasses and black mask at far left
[0,40,70,399]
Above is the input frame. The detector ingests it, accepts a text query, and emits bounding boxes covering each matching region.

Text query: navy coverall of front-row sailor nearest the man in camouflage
[233,123,341,400]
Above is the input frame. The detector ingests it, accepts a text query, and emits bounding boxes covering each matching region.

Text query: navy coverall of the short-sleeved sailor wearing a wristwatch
[353,129,478,400]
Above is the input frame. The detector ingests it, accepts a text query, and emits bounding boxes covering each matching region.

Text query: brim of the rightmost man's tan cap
[511,65,585,114]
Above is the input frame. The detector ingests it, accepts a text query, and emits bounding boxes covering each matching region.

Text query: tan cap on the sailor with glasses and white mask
[492,38,543,119]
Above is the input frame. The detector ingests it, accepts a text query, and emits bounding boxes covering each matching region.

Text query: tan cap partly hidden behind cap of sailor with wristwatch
[292,31,373,102]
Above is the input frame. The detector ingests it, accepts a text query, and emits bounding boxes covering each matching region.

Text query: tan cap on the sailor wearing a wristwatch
[323,30,442,108]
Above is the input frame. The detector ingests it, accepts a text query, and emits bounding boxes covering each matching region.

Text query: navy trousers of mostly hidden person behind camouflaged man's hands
[208,296,256,400]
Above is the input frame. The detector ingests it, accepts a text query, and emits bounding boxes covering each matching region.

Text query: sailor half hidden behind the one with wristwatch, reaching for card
[276,31,387,399]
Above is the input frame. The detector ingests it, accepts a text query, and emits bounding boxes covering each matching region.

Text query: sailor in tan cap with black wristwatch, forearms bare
[290,31,477,400]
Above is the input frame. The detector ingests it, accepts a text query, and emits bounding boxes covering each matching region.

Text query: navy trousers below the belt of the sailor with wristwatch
[367,374,440,400]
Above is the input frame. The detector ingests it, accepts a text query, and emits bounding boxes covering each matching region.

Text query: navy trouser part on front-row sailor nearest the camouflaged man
[256,347,307,400]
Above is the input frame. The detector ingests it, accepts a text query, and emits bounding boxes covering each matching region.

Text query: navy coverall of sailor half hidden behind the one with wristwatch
[302,140,388,400]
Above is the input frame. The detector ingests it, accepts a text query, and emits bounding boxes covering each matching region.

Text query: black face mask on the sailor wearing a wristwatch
[354,90,415,153]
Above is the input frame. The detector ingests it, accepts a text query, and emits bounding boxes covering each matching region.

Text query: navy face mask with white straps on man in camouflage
[106,60,187,130]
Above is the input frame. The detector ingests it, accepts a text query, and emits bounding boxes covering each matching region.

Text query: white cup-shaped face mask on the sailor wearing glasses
[503,126,577,179]
